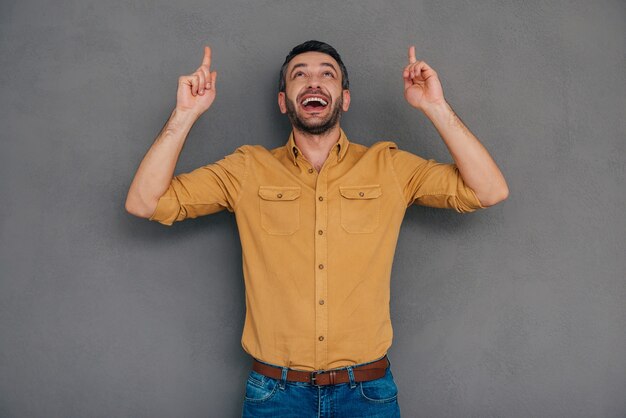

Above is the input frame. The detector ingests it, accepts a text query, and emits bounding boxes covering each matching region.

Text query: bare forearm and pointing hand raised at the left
[125,46,217,218]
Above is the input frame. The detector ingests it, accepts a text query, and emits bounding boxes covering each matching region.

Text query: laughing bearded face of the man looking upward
[278,52,350,135]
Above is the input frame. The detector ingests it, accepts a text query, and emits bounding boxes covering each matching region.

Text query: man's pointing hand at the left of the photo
[176,46,217,117]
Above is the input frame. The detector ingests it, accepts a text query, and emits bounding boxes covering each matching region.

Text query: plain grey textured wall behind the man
[0,0,626,417]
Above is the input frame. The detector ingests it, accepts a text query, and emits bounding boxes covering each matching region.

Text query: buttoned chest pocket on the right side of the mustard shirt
[339,184,383,234]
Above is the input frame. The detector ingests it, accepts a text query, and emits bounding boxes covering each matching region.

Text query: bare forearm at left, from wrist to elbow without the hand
[126,109,197,218]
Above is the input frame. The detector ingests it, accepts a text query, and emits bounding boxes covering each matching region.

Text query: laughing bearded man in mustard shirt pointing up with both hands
[126,41,508,417]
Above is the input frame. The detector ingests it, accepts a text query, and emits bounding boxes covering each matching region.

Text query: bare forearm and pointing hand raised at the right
[402,46,509,207]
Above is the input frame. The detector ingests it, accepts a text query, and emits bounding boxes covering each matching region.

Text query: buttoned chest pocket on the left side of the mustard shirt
[259,186,300,235]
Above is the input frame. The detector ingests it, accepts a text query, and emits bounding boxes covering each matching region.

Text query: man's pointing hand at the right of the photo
[402,46,445,110]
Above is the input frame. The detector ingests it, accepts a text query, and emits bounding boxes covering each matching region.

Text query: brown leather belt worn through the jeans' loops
[252,354,389,386]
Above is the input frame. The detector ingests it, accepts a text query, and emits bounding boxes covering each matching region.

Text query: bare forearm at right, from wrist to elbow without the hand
[424,102,509,206]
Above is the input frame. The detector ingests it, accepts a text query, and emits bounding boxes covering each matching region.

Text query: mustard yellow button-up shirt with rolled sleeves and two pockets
[150,126,483,371]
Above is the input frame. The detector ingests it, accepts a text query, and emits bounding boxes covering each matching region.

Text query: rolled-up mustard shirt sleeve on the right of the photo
[390,148,485,213]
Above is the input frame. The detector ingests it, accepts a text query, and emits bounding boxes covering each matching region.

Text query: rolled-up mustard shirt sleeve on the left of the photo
[149,145,248,226]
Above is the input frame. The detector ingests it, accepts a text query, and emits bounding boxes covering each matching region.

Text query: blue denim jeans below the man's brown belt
[242,359,400,418]
